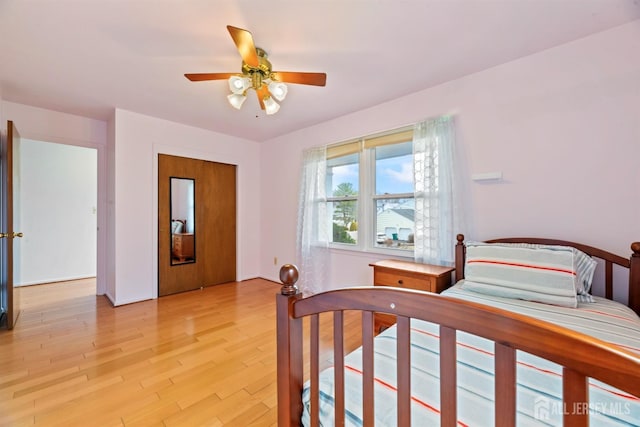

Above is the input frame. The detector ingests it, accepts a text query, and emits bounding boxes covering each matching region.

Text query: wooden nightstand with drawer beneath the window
[369,259,455,332]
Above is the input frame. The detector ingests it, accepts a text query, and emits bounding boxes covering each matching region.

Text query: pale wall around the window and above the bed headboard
[260,21,640,296]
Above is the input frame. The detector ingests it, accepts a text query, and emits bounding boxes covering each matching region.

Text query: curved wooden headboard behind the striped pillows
[455,234,640,315]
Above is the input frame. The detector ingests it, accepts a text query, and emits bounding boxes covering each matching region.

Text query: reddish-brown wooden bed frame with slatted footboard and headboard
[276,235,640,426]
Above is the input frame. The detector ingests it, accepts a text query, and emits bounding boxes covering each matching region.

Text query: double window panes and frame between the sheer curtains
[326,128,415,256]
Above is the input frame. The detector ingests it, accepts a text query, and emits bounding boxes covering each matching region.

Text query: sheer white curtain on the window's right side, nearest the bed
[413,116,464,265]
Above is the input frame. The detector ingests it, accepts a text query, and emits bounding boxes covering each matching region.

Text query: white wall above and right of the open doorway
[0,101,107,294]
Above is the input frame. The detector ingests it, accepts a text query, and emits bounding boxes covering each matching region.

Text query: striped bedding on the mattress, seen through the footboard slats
[302,282,640,426]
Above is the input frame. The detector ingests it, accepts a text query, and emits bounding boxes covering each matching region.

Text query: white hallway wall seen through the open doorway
[14,139,97,286]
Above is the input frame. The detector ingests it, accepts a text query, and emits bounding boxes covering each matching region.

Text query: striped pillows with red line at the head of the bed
[463,242,595,307]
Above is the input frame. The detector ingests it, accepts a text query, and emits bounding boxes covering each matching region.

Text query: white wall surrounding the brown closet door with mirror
[107,109,261,305]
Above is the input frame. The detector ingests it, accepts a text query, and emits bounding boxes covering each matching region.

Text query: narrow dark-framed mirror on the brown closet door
[169,177,196,265]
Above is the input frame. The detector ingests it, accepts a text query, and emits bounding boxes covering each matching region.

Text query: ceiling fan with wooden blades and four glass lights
[184,25,327,114]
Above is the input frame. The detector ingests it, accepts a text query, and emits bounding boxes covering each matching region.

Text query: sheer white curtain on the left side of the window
[296,147,331,295]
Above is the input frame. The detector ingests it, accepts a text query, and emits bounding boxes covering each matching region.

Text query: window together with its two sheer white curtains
[296,116,458,293]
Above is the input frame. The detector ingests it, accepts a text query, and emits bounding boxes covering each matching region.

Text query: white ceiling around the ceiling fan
[0,0,640,141]
